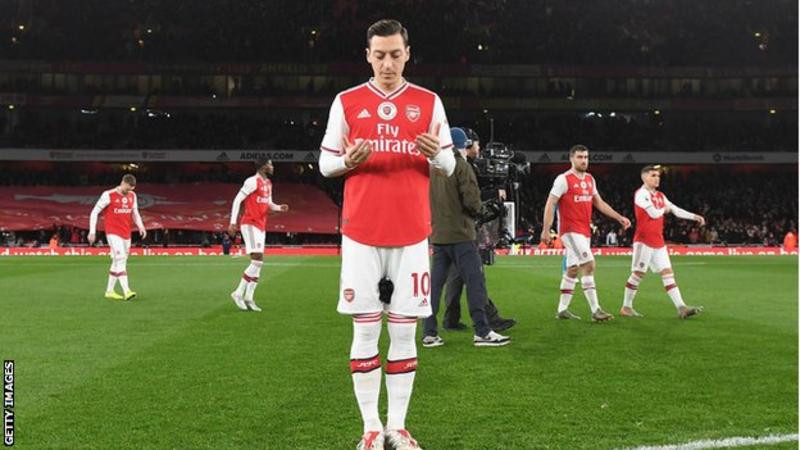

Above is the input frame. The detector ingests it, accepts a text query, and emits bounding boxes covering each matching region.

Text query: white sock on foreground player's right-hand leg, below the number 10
[386,314,417,430]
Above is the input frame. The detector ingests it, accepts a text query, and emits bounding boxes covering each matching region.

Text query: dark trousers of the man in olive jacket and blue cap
[424,241,491,336]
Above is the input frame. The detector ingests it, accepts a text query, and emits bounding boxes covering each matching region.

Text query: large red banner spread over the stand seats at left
[0,183,339,234]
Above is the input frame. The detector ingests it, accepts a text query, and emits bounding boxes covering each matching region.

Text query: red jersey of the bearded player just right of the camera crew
[550,169,598,238]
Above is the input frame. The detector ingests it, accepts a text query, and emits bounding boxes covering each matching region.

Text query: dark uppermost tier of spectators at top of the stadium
[0,0,797,66]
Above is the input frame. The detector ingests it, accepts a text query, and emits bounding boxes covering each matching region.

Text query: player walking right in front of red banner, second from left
[228,158,289,312]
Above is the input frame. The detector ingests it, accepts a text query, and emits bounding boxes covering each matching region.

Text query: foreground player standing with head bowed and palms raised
[319,20,455,450]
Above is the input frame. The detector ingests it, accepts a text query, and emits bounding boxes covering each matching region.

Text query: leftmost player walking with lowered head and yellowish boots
[87,174,147,300]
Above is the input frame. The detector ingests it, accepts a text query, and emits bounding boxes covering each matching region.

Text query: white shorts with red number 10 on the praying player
[336,235,431,317]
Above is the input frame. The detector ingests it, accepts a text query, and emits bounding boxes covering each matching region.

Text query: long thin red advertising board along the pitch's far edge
[0,245,798,256]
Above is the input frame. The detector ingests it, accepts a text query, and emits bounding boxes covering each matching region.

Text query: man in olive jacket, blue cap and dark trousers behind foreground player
[422,128,511,347]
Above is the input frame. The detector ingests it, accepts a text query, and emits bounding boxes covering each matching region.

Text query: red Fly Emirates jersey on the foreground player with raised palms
[320,80,454,247]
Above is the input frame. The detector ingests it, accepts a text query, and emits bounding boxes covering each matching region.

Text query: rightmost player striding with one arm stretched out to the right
[619,165,706,319]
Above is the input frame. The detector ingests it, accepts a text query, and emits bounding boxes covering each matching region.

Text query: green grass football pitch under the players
[0,257,798,450]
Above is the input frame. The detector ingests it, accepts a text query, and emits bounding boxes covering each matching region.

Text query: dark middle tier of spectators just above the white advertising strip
[0,110,797,151]
